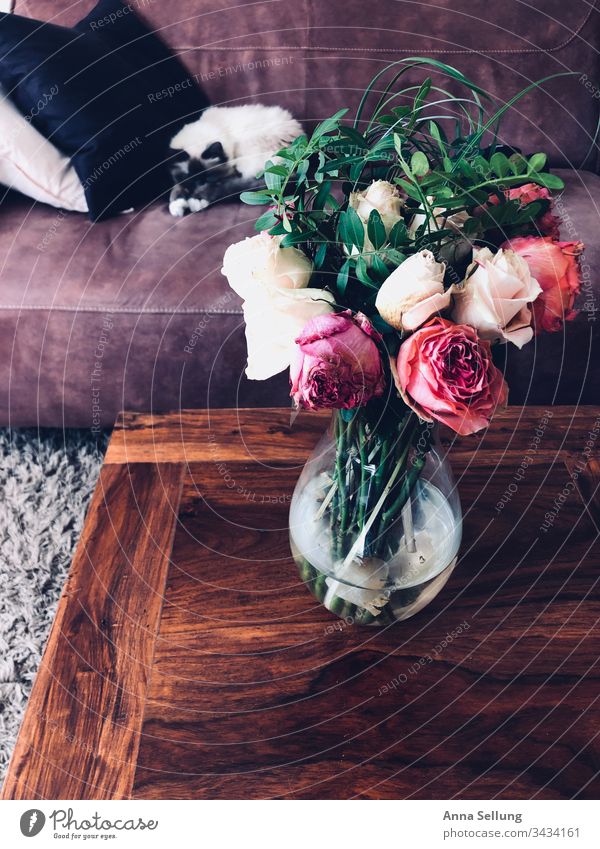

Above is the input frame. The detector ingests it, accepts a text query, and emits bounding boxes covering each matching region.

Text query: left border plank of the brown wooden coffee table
[2,464,181,799]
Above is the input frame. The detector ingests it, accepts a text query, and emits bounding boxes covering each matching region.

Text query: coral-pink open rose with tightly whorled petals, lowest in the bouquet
[392,318,508,436]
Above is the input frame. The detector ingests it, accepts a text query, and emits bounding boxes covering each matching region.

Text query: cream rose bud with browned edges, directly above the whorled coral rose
[375,250,451,330]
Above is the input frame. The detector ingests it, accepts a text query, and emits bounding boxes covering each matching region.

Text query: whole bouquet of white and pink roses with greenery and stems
[223,58,583,621]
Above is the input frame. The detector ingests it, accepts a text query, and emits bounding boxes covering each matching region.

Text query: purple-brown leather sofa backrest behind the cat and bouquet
[9,0,600,170]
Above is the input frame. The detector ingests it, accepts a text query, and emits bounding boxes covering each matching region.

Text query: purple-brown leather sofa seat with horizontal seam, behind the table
[0,172,600,427]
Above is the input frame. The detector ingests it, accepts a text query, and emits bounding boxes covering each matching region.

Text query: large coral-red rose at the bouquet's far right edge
[504,236,583,333]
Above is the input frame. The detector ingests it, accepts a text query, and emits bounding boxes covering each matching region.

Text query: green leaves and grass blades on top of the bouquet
[241,57,563,318]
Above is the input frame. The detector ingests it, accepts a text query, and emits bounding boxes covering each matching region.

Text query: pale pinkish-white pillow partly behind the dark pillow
[0,92,88,212]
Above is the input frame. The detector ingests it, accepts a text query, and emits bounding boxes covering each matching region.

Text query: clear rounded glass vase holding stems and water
[290,406,462,625]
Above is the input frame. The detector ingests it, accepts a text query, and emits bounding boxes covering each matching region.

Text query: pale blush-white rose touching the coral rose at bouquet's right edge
[452,248,542,348]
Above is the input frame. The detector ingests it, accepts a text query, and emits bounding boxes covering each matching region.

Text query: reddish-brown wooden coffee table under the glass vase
[3,407,600,799]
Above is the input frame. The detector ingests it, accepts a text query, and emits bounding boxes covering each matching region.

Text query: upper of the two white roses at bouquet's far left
[222,233,313,300]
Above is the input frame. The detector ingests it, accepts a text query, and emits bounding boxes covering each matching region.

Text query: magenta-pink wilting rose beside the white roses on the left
[290,310,385,410]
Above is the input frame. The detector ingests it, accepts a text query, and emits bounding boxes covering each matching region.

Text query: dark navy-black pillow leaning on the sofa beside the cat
[0,0,208,221]
